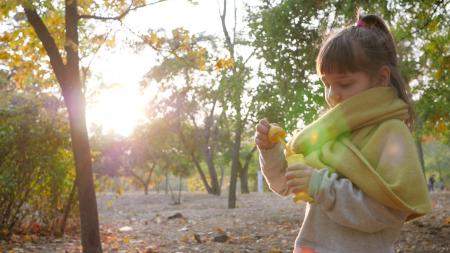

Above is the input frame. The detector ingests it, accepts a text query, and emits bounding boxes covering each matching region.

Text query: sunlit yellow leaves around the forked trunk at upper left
[0,0,127,89]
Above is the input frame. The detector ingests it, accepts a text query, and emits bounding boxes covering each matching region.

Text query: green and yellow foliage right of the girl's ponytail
[391,1,450,143]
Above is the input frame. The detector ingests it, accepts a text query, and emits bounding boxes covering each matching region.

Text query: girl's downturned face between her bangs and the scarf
[321,72,375,107]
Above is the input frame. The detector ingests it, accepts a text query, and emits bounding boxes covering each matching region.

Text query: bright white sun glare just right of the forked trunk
[86,85,146,136]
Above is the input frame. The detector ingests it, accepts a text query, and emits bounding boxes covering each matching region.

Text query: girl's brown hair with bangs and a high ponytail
[316,10,415,130]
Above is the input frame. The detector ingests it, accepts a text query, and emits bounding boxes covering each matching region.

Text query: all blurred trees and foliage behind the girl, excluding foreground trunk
[0,0,450,250]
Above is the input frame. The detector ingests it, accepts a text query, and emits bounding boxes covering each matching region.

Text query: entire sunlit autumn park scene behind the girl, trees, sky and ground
[0,0,450,252]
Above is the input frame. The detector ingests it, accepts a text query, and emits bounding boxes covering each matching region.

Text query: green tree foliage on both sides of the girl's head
[249,0,450,136]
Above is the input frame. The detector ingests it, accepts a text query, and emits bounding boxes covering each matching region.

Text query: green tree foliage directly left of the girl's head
[249,0,327,129]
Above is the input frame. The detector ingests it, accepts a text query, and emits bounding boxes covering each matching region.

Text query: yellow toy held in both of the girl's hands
[269,124,314,203]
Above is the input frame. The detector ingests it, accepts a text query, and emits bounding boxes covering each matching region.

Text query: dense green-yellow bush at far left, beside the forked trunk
[0,92,74,231]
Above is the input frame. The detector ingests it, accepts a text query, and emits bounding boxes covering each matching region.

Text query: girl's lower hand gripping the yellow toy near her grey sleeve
[284,164,314,194]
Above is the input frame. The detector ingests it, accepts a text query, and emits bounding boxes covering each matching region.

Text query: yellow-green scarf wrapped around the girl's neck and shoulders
[288,87,431,220]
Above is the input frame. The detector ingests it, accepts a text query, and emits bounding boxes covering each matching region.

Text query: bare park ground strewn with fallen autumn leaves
[0,192,450,253]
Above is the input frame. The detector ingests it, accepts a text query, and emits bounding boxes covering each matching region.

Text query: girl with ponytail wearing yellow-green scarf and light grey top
[255,11,431,253]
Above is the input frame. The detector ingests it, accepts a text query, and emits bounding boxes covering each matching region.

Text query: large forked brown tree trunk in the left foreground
[23,0,102,253]
